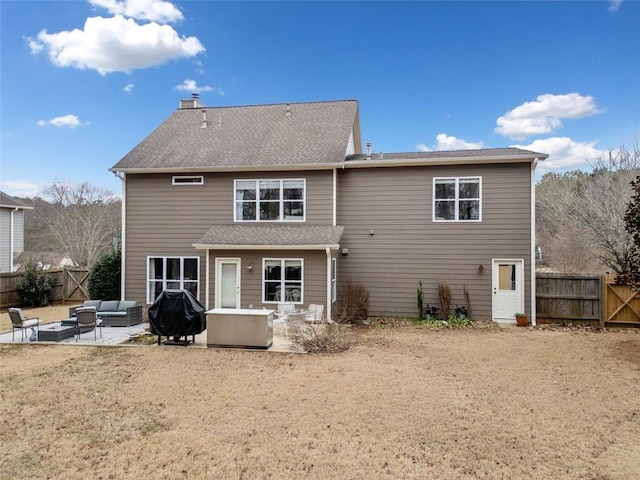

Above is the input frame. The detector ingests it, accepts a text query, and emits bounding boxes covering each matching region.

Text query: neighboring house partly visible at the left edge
[0,192,33,272]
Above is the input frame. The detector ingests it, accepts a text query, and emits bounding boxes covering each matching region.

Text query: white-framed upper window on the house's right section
[433,177,482,222]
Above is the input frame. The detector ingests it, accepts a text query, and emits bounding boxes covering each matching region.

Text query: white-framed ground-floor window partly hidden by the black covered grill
[147,257,200,303]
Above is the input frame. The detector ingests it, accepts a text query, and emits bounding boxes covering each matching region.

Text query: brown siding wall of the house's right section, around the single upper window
[338,164,531,319]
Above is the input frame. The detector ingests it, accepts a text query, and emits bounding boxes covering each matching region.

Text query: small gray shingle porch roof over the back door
[196,225,344,248]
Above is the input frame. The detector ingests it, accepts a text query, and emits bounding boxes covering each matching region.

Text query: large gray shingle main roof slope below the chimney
[111,100,358,171]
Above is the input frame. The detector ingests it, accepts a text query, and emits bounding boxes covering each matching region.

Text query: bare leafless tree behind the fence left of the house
[34,180,121,267]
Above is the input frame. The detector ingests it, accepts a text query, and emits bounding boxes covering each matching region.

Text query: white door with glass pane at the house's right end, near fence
[492,260,524,323]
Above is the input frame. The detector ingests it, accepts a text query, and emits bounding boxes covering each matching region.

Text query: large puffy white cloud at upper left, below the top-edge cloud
[27,15,205,75]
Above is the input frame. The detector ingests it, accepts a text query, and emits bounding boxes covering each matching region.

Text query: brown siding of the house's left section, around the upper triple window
[125,171,333,304]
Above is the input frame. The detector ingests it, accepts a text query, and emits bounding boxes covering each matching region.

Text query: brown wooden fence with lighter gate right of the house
[536,273,640,327]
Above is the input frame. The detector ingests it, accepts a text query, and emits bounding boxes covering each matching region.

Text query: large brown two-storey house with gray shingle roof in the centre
[111,98,547,321]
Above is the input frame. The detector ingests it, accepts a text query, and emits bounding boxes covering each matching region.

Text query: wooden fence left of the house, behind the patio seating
[0,268,89,308]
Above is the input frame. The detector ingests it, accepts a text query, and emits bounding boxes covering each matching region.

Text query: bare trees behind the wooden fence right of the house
[536,142,640,273]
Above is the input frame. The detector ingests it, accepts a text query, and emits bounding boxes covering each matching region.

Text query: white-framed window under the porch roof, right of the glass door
[262,258,304,303]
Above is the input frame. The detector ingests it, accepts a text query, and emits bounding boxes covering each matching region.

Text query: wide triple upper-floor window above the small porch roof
[235,179,306,222]
